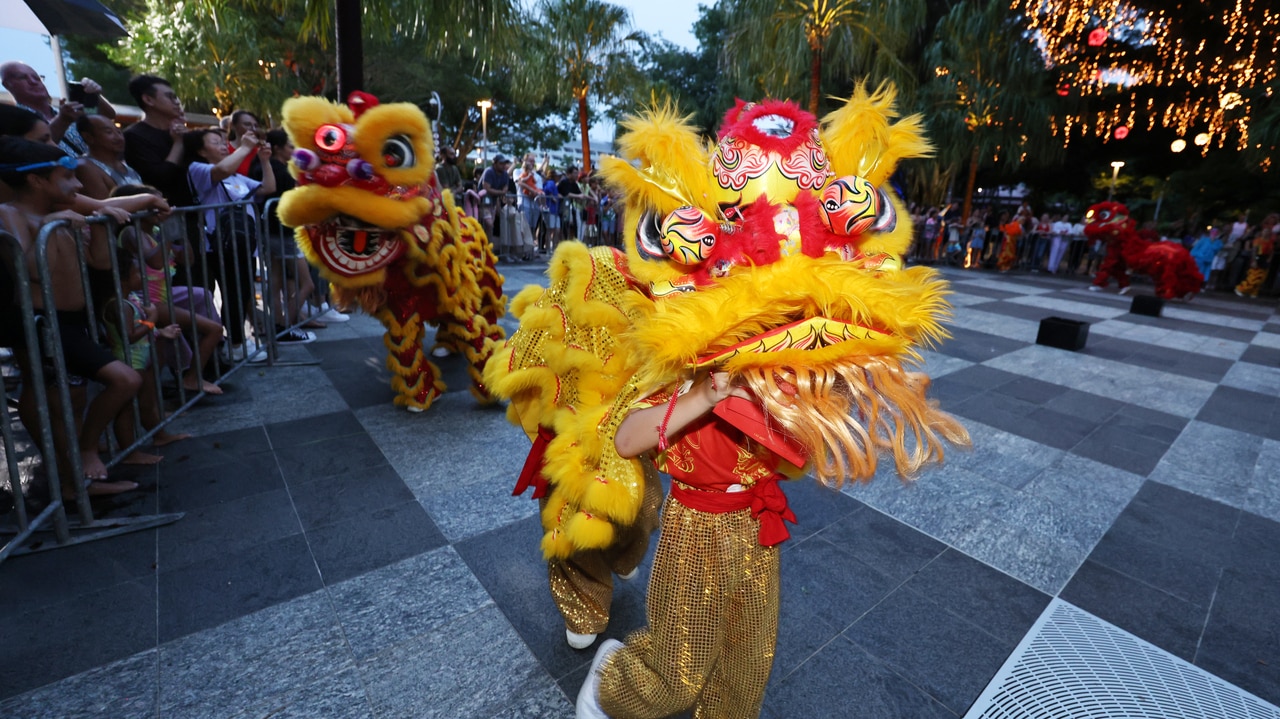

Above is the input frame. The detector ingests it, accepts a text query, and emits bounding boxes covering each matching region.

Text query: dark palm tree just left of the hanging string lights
[920,0,1062,219]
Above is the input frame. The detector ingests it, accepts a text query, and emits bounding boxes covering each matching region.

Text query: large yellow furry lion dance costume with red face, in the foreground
[485,88,969,715]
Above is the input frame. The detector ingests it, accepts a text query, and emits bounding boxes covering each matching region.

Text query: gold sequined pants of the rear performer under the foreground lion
[541,462,662,635]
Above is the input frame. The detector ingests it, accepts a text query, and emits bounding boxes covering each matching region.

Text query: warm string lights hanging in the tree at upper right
[1010,0,1280,152]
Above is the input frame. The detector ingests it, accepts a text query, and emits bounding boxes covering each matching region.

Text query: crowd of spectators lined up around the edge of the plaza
[0,60,1277,499]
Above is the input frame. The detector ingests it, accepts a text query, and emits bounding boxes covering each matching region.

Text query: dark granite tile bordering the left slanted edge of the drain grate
[845,589,1009,714]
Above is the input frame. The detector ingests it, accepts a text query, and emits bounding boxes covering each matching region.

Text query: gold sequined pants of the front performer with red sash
[600,491,778,719]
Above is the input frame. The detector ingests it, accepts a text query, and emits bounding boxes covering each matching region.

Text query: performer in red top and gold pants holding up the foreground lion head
[577,371,795,716]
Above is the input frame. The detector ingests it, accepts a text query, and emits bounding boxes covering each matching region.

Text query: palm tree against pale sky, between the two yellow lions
[516,0,644,174]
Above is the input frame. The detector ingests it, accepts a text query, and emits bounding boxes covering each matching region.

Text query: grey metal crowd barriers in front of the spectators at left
[0,200,319,562]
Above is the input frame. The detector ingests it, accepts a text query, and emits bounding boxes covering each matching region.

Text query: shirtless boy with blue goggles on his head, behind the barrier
[0,137,142,498]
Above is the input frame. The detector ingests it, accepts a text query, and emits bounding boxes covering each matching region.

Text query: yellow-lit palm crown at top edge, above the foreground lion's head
[722,0,924,115]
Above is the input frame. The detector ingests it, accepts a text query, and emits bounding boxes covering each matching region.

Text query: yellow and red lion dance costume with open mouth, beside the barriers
[279,92,507,411]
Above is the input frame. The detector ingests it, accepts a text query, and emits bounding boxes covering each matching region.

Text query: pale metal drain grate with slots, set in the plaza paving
[965,599,1280,719]
